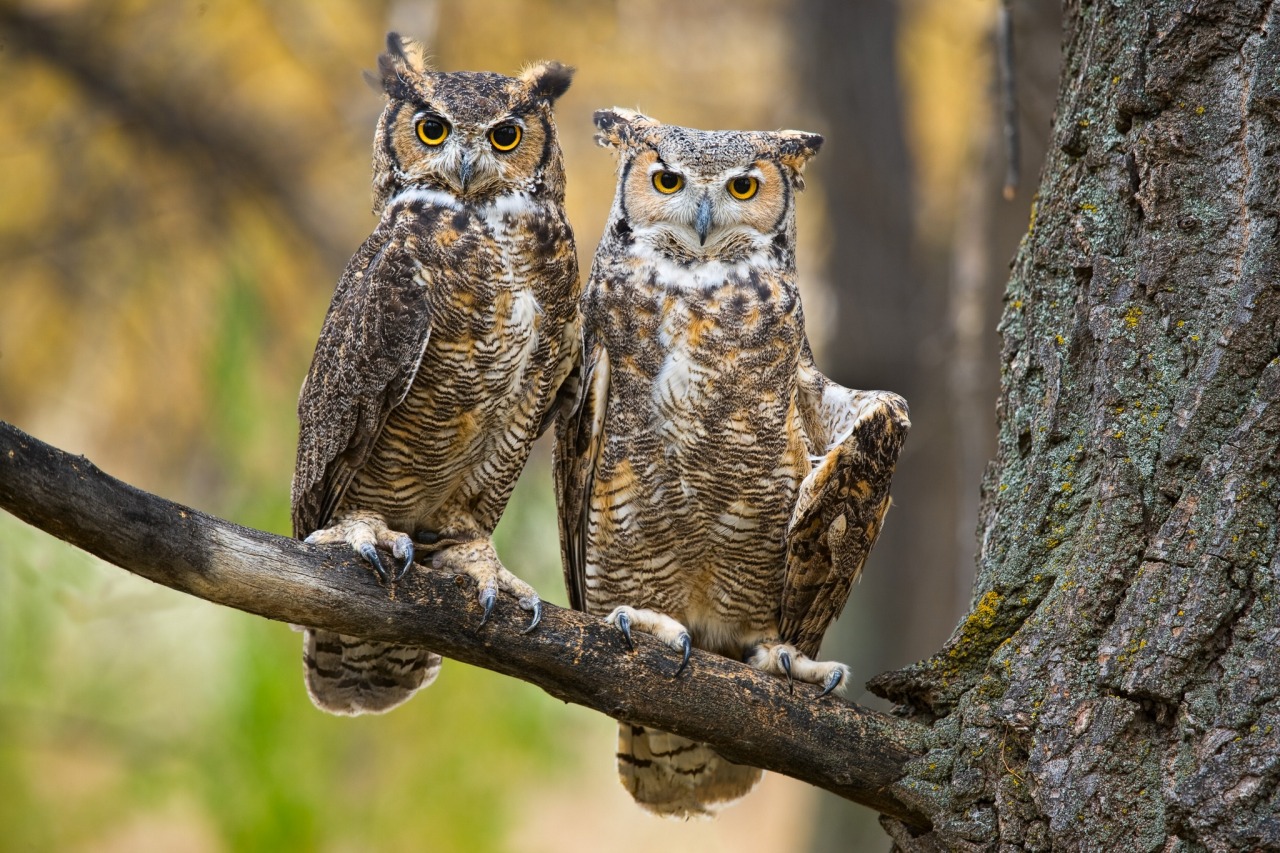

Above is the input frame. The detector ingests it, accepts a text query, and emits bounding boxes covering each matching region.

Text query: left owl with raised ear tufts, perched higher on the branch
[293,33,581,715]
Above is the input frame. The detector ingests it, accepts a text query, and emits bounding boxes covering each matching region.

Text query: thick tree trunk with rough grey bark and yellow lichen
[873,0,1280,850]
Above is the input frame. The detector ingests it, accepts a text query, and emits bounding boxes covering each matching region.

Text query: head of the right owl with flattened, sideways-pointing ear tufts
[595,108,822,263]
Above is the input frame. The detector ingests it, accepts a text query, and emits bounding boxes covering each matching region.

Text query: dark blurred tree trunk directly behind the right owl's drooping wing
[794,0,931,850]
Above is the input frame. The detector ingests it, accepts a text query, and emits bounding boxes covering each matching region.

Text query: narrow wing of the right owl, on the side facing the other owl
[554,342,609,610]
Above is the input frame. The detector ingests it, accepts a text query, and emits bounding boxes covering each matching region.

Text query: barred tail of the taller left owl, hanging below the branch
[302,628,440,716]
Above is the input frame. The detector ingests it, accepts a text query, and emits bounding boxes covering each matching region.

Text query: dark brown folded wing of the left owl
[293,218,435,537]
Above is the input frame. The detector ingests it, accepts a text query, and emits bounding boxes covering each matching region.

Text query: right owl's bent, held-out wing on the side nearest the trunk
[780,362,911,657]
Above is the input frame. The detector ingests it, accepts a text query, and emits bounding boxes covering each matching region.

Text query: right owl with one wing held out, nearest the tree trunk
[556,109,910,817]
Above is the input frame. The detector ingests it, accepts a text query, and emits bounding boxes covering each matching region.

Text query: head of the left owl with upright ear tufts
[374,32,573,213]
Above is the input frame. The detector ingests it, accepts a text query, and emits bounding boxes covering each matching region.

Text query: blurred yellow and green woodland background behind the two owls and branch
[0,0,1059,852]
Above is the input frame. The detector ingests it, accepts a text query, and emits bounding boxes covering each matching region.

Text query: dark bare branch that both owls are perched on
[0,421,931,829]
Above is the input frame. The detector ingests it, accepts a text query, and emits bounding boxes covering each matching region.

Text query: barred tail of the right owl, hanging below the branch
[618,722,763,818]
